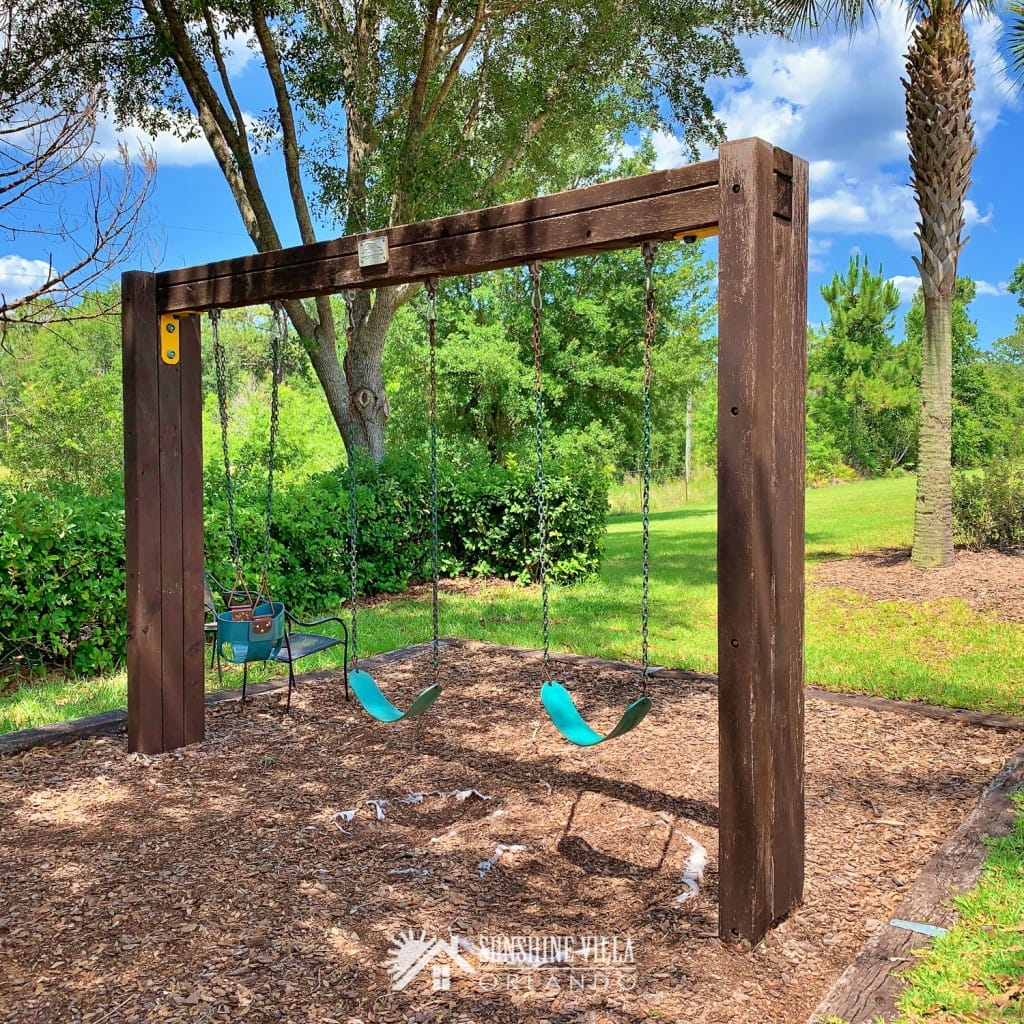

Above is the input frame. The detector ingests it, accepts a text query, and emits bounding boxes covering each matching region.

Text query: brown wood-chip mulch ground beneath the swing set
[0,642,1020,1024]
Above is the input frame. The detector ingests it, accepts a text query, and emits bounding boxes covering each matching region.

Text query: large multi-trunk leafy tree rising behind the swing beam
[28,0,765,459]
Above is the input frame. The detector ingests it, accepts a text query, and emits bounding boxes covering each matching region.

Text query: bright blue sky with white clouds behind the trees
[0,7,1024,347]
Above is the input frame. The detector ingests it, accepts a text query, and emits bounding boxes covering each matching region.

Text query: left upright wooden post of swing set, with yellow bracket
[121,271,205,754]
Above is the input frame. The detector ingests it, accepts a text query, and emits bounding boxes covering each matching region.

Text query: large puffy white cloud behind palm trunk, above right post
[638,0,1020,251]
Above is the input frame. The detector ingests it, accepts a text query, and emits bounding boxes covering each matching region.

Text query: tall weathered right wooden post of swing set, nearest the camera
[718,139,807,943]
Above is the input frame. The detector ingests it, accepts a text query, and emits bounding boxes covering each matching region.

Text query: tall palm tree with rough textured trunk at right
[780,0,1024,567]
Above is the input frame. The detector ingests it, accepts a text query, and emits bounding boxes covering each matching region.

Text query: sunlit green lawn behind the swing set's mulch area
[0,477,1024,731]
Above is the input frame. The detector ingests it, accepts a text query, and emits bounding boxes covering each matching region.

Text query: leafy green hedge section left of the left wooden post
[0,489,127,672]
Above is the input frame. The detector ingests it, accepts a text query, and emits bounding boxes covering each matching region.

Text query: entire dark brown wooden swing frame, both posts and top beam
[122,139,808,943]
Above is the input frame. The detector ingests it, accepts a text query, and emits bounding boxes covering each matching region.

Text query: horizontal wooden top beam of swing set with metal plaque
[156,160,718,313]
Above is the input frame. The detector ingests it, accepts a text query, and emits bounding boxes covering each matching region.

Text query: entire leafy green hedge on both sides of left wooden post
[0,455,608,673]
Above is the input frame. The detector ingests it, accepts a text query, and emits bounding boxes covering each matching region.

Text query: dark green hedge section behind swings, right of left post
[206,447,608,602]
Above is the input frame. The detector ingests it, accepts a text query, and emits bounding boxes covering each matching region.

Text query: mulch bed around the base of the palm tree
[810,548,1024,623]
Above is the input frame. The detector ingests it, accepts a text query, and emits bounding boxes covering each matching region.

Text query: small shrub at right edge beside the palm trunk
[953,461,1024,551]
